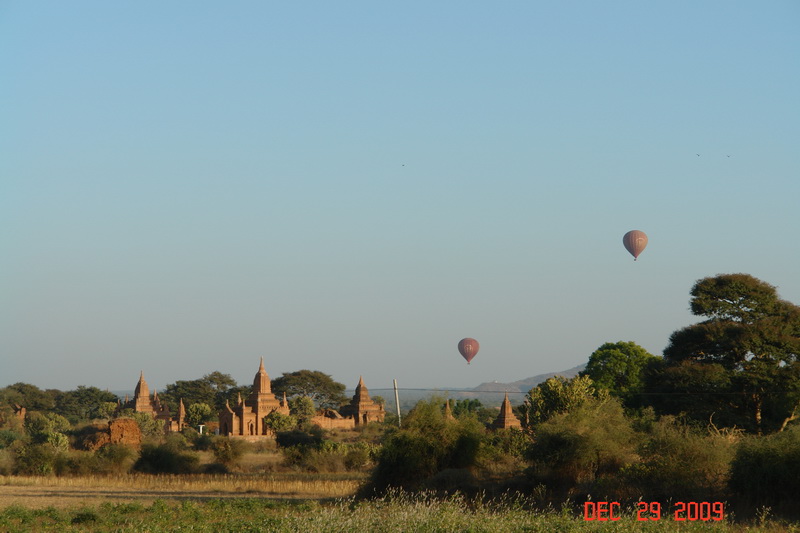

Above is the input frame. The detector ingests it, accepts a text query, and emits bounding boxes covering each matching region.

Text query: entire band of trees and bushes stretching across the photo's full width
[0,274,800,518]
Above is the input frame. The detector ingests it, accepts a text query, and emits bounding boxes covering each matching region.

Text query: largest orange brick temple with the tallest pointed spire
[219,357,289,437]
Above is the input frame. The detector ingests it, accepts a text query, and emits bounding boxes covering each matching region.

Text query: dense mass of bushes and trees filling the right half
[365,274,800,518]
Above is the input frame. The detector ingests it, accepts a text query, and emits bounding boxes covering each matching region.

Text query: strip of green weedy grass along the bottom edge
[0,493,800,533]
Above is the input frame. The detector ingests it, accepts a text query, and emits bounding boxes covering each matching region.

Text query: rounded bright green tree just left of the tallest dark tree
[581,341,659,404]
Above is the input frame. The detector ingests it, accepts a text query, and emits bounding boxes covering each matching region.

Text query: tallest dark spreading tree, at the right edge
[650,274,800,433]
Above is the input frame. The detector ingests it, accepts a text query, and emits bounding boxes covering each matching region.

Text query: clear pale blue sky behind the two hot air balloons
[0,0,800,390]
